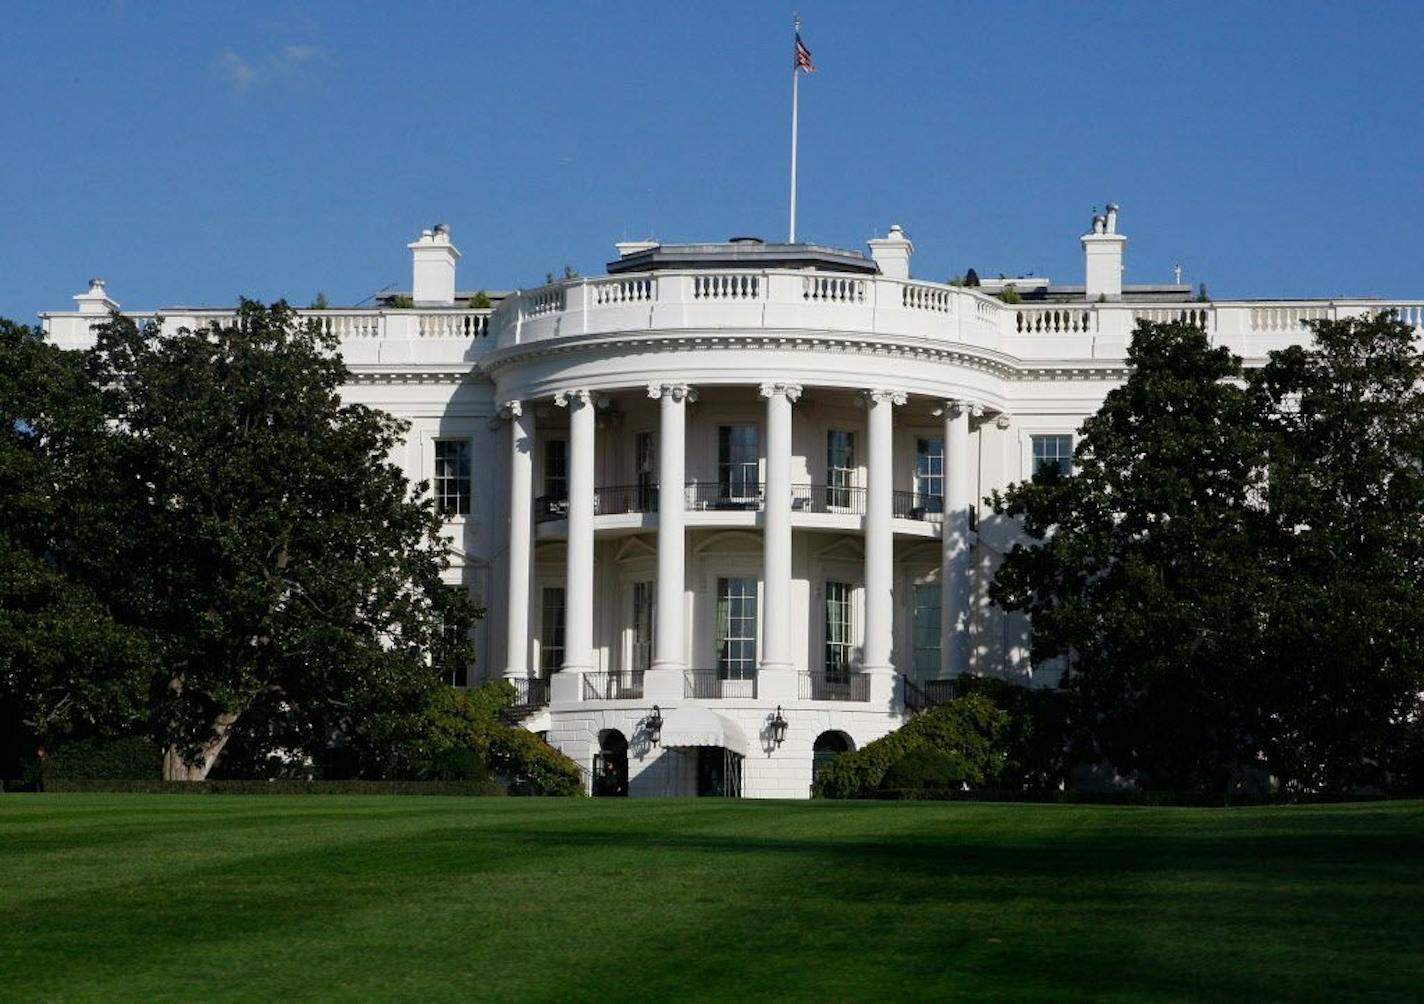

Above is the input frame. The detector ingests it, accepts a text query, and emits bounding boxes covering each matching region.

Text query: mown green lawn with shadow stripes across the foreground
[0,795,1424,1003]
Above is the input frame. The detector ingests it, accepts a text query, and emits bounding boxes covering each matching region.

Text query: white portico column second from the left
[554,390,594,674]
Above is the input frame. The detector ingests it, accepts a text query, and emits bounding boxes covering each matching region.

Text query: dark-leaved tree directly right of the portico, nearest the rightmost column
[990,322,1272,790]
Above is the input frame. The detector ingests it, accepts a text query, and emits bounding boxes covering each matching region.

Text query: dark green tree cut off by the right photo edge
[1253,315,1424,790]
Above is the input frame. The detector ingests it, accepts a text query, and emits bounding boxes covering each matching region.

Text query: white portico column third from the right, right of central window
[760,383,802,672]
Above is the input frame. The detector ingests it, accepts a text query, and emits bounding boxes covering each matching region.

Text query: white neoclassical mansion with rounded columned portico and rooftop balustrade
[43,205,1424,798]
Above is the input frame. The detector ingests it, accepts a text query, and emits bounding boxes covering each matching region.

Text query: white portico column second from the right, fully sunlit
[862,390,906,675]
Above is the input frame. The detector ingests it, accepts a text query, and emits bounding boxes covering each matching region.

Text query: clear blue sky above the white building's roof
[0,0,1424,320]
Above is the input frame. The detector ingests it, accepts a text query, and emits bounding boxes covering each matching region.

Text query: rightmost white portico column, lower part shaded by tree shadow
[940,400,983,679]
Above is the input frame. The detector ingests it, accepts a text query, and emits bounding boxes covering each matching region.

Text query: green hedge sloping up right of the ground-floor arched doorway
[816,694,1008,799]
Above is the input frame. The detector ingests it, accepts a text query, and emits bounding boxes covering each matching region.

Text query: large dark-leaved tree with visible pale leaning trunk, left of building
[74,300,476,779]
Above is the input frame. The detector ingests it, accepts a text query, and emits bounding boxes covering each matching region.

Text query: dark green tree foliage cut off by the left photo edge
[0,320,150,770]
